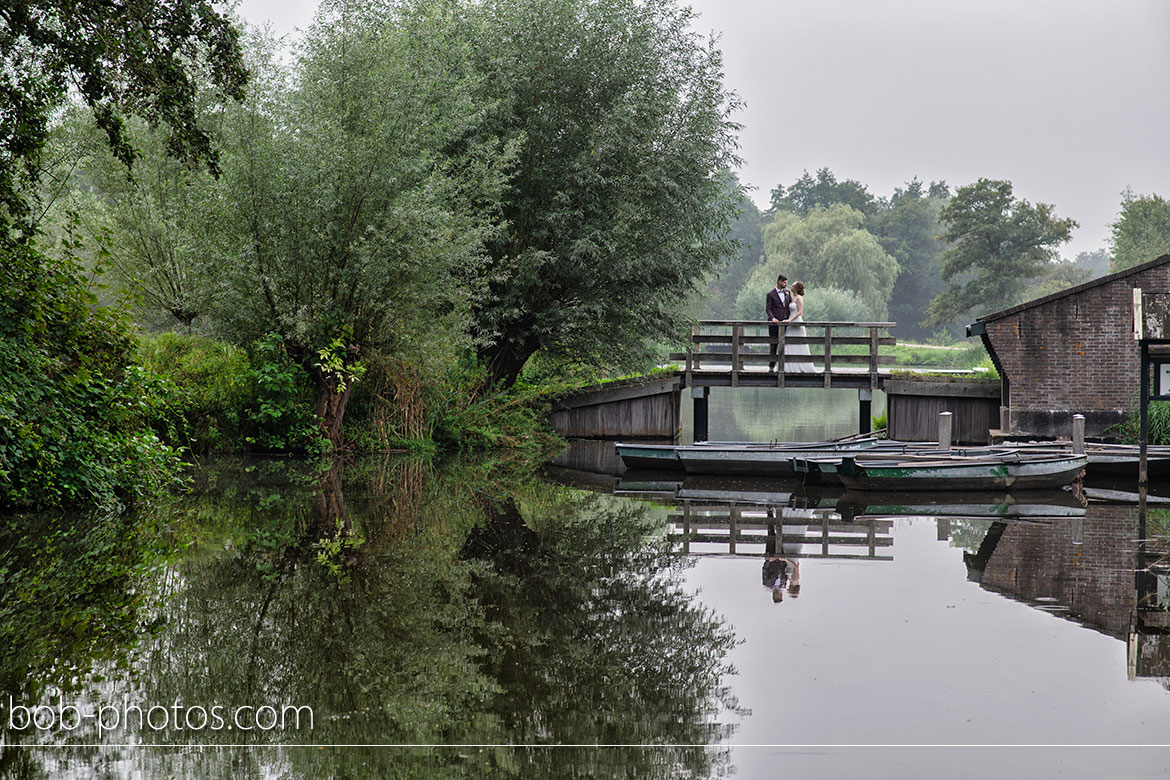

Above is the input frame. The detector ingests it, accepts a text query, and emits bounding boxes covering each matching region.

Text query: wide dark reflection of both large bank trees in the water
[11,462,734,780]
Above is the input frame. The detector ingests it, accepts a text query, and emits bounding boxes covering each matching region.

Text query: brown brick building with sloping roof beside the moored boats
[968,255,1170,437]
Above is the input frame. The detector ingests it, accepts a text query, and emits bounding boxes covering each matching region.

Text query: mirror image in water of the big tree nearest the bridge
[464,495,736,778]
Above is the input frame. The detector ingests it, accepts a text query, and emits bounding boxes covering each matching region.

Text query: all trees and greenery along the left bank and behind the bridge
[0,0,1164,508]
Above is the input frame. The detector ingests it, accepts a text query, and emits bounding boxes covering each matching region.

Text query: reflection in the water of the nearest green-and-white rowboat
[837,490,1085,520]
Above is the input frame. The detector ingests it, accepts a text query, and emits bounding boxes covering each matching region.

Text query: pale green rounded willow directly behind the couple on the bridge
[737,203,897,319]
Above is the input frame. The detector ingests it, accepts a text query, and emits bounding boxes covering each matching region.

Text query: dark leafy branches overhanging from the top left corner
[0,0,247,236]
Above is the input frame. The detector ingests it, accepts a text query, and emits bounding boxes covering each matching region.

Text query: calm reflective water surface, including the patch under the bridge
[0,391,1170,779]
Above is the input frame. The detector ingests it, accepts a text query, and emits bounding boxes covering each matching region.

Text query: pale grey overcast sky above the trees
[240,0,1170,257]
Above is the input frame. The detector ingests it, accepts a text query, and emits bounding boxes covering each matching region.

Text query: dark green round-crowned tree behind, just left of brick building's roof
[927,179,1076,325]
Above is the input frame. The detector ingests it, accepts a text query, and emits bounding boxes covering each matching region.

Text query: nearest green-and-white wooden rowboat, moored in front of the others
[819,451,1088,491]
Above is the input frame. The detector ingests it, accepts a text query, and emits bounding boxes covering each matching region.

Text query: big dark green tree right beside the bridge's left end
[469,0,736,385]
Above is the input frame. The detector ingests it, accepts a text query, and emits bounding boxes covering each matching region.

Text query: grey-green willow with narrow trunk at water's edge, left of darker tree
[206,0,501,443]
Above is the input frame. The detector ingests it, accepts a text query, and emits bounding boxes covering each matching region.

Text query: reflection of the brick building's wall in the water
[966,504,1137,640]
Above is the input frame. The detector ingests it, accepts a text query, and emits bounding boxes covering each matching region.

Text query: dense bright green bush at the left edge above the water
[0,244,179,508]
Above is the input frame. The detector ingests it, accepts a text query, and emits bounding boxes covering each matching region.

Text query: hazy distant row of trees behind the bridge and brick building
[694,168,1170,340]
